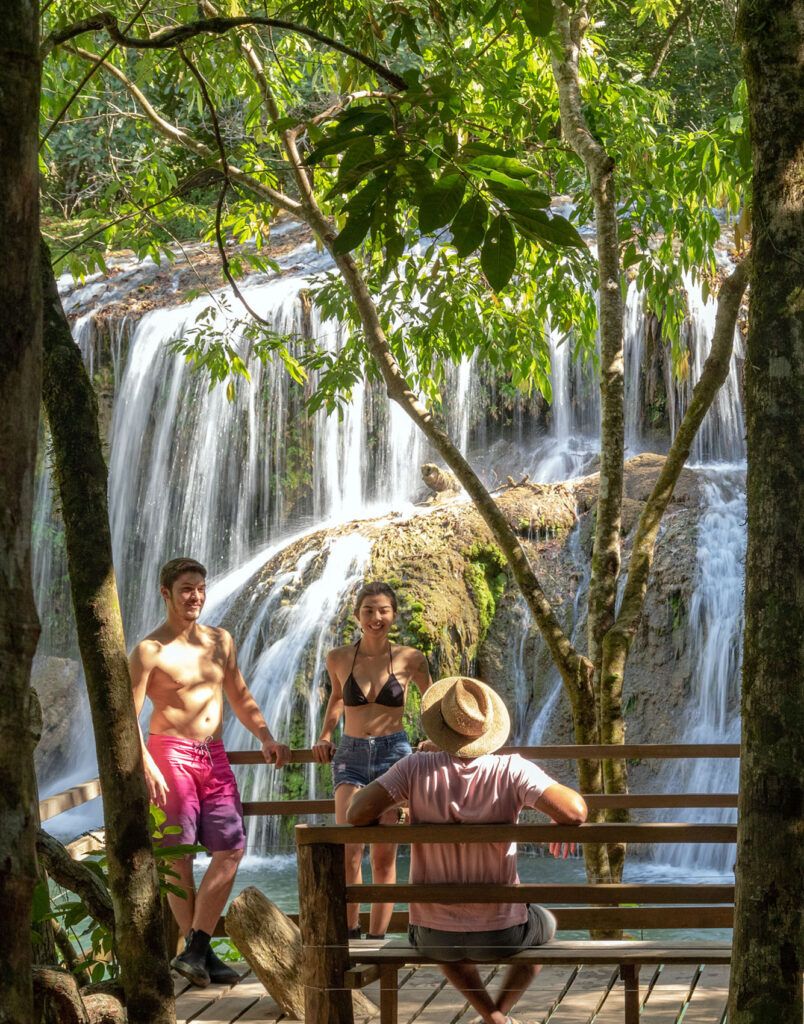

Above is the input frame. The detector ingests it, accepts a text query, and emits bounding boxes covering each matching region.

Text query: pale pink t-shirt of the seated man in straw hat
[378,751,554,932]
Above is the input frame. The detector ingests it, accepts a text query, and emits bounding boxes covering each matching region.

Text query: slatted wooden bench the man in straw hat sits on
[296,748,736,1024]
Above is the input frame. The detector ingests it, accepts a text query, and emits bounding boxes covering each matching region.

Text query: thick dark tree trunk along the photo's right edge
[728,0,804,1024]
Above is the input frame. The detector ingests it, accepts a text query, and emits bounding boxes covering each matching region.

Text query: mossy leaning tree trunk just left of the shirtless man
[42,246,175,1024]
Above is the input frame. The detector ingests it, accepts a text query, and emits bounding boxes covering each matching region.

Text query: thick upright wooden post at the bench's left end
[296,825,354,1024]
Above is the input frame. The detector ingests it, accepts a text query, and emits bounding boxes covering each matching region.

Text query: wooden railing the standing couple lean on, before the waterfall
[39,743,739,821]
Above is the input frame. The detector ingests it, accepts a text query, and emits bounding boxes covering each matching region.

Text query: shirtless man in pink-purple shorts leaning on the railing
[129,558,290,987]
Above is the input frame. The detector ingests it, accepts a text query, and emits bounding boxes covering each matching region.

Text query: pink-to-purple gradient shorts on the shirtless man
[147,734,246,852]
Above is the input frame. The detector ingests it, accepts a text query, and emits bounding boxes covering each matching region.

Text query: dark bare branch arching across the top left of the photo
[41,11,408,90]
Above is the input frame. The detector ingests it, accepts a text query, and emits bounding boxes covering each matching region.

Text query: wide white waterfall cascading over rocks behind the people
[34,246,745,872]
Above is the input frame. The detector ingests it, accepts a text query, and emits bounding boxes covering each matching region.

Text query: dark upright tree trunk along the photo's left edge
[0,0,42,1024]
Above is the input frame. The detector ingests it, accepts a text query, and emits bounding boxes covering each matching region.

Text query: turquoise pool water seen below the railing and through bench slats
[205,851,734,942]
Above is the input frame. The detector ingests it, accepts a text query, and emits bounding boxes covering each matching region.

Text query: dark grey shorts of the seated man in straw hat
[408,903,555,963]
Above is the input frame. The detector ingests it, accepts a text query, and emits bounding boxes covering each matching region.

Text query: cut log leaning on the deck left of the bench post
[226,886,379,1021]
